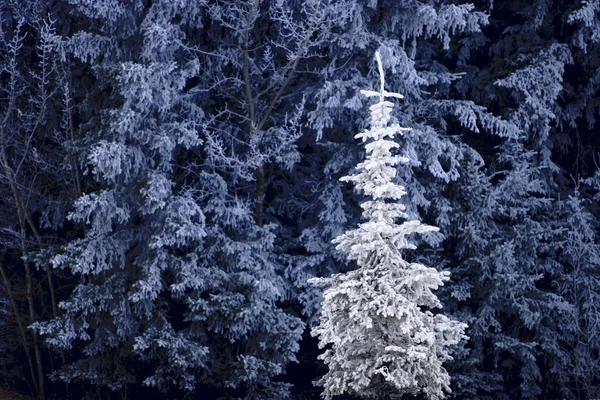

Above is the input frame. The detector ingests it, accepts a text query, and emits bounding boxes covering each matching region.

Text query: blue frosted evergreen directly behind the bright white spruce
[288,1,508,324]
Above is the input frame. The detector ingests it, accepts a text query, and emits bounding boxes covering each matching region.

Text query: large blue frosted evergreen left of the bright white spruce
[35,0,303,399]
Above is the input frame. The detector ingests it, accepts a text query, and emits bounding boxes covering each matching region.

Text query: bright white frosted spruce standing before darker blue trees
[311,53,467,399]
